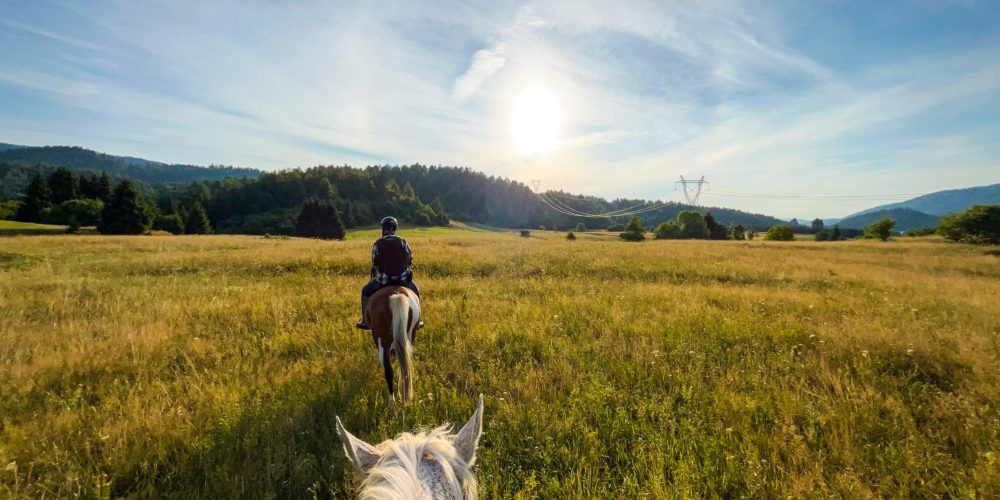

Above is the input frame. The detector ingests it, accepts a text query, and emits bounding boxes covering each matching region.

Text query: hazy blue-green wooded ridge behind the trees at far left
[0,145,263,190]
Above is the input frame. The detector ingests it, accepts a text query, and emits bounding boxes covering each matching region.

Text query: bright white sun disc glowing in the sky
[510,89,560,156]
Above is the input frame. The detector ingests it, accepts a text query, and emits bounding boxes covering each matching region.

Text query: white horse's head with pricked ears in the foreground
[337,394,483,500]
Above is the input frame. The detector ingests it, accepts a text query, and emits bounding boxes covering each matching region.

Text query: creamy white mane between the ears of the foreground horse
[361,425,478,500]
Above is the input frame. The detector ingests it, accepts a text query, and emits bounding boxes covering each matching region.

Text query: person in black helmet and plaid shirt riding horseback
[355,217,424,330]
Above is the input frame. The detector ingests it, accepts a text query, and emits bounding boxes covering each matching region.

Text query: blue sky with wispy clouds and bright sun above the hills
[0,0,1000,217]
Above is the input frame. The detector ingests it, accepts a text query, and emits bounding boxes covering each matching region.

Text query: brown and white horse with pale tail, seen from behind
[365,286,420,407]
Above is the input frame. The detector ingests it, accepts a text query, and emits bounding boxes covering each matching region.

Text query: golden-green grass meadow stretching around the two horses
[0,228,1000,498]
